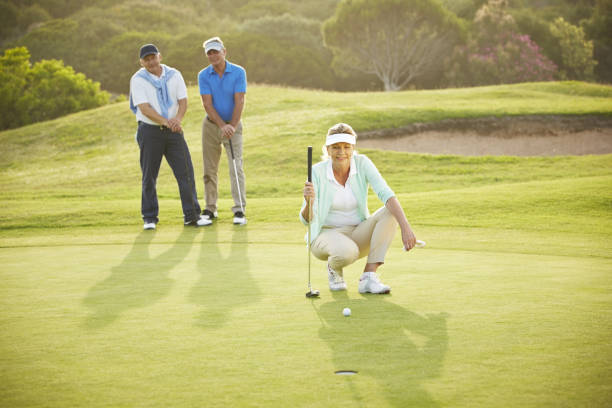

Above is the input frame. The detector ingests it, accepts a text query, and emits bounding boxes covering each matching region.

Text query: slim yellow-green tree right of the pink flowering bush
[550,17,597,80]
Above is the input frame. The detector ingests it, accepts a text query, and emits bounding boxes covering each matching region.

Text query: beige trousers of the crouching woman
[311,207,397,273]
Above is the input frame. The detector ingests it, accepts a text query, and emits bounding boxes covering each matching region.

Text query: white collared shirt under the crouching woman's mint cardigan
[324,157,361,227]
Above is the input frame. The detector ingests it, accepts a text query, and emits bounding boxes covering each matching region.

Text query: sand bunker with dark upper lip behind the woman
[357,116,612,156]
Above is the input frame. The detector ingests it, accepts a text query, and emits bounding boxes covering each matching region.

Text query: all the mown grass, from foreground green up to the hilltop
[0,82,612,407]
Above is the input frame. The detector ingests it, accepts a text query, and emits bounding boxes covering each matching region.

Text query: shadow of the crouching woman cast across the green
[313,292,448,407]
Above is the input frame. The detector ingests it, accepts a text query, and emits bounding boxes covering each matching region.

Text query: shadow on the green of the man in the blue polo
[189,224,261,329]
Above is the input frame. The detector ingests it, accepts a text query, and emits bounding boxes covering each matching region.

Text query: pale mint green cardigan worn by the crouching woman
[300,153,395,242]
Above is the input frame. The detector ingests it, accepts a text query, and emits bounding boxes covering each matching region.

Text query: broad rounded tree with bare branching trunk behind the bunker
[323,0,461,91]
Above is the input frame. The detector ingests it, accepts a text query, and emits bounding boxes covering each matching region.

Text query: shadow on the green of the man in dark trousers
[83,227,198,329]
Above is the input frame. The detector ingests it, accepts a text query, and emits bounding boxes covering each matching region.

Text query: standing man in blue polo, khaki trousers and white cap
[198,37,247,225]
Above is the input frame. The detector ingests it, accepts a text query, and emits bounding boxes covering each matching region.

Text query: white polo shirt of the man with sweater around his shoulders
[130,65,187,125]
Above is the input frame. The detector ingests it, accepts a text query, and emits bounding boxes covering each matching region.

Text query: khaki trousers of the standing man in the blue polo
[202,117,246,213]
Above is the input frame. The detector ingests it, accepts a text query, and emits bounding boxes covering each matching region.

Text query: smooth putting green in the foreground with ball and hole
[0,223,612,407]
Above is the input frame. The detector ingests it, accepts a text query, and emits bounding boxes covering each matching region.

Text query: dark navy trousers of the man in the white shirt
[136,122,200,223]
